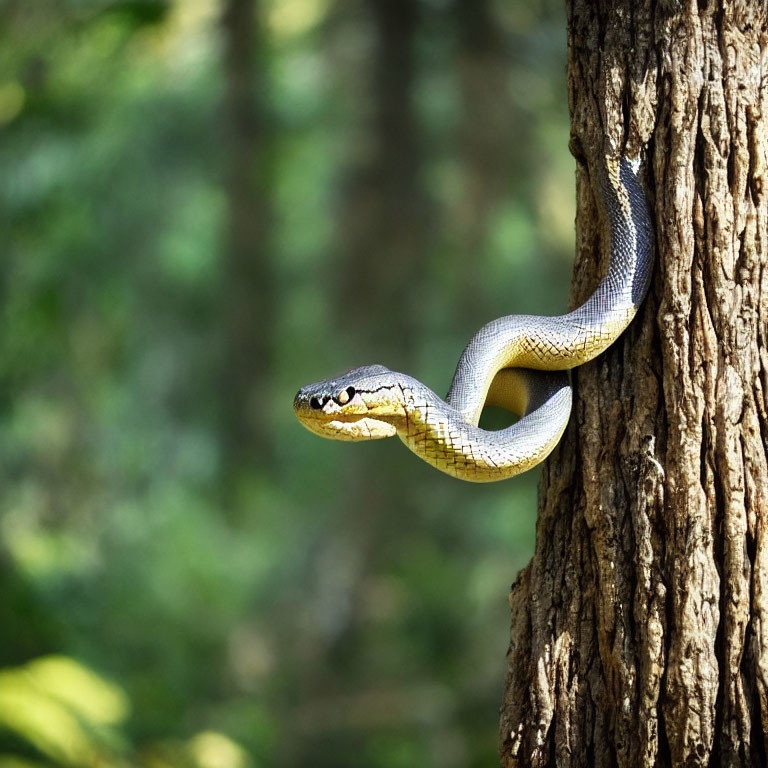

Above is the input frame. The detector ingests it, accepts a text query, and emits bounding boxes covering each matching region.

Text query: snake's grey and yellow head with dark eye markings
[293,365,405,440]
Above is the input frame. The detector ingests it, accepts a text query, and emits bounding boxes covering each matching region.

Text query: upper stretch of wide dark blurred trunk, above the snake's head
[336,0,428,368]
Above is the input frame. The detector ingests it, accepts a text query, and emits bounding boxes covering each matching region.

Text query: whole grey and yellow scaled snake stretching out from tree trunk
[293,155,653,482]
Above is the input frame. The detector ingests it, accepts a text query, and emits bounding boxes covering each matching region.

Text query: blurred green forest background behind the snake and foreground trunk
[0,0,574,768]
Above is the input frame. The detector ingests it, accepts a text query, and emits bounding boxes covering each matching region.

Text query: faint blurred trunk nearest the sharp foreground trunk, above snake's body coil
[452,0,516,327]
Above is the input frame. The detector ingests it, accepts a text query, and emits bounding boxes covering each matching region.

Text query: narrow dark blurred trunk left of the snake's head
[221,0,275,487]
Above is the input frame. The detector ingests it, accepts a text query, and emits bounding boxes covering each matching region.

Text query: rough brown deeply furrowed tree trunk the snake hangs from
[501,0,768,766]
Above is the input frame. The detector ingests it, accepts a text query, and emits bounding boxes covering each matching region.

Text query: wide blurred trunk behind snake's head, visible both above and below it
[298,0,436,720]
